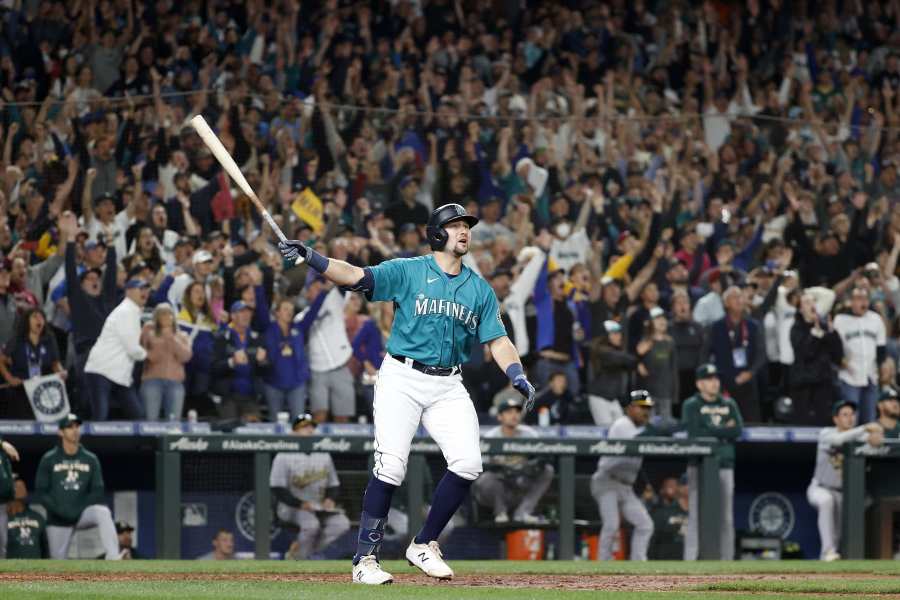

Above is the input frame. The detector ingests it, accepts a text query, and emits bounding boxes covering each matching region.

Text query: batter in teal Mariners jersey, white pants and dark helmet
[279,204,534,584]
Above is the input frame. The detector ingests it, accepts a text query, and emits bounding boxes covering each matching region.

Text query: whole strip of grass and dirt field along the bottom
[0,561,900,600]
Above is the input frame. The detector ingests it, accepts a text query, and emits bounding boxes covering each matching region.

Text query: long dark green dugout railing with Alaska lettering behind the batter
[155,433,721,560]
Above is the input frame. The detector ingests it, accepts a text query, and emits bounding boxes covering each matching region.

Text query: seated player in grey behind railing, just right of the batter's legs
[472,398,554,523]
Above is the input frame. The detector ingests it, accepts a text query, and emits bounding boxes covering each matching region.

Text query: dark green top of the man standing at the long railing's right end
[681,393,744,469]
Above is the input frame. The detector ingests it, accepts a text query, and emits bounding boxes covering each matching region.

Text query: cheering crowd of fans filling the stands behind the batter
[0,0,900,425]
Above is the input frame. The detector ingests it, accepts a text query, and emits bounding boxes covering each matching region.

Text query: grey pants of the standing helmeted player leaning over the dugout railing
[591,473,653,560]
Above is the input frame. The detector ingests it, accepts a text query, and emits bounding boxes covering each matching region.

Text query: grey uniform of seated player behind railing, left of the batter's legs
[269,452,350,559]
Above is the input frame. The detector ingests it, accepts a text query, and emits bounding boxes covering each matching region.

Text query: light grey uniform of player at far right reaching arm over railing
[806,426,869,558]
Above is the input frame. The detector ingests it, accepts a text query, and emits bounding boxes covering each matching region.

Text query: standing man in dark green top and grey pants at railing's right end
[681,363,744,560]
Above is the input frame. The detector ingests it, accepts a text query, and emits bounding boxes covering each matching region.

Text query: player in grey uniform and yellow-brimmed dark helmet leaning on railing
[591,390,653,560]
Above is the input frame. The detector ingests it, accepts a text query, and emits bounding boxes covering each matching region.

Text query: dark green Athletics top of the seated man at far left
[35,446,104,526]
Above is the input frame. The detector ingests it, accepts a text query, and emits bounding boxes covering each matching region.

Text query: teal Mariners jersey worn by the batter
[370,254,506,367]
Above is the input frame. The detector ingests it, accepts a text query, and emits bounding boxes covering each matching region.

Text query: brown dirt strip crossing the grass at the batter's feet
[0,572,900,600]
